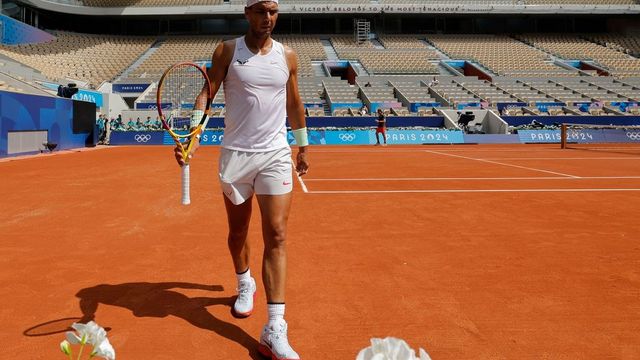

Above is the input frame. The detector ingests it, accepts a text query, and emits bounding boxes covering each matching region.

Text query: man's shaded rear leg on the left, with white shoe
[222,194,256,317]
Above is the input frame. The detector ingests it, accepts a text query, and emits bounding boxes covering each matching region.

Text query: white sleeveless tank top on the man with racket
[222,37,289,152]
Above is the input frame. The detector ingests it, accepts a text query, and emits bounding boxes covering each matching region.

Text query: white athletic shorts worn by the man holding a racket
[218,147,293,205]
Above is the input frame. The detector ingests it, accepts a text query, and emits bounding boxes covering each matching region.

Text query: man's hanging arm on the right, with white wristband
[285,47,309,175]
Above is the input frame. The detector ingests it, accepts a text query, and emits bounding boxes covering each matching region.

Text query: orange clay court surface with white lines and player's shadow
[0,145,640,360]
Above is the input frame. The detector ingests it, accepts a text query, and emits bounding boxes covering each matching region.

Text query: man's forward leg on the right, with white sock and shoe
[256,193,300,359]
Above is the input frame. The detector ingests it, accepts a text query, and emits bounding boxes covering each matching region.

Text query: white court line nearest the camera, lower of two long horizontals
[309,188,640,194]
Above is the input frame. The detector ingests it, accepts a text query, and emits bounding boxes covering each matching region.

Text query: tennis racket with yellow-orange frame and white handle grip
[156,62,213,205]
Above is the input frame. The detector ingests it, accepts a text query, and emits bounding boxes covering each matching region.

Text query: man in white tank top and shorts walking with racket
[176,0,309,359]
